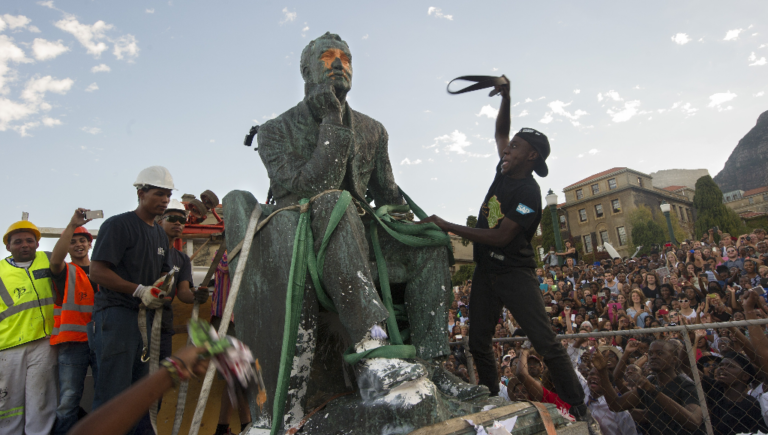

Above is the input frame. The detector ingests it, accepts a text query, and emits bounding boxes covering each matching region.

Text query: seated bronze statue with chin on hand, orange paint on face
[223,33,488,434]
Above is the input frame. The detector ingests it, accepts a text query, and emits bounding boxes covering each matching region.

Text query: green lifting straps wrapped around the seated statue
[270,190,453,435]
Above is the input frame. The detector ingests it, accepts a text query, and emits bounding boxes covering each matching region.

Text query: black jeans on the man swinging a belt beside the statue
[469,265,584,405]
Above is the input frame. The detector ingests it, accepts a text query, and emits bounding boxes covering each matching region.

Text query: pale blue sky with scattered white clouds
[0,0,768,255]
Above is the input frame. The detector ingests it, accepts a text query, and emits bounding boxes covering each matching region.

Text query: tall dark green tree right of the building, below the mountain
[693,175,746,238]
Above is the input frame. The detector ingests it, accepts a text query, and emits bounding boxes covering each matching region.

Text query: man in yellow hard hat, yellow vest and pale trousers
[0,221,63,435]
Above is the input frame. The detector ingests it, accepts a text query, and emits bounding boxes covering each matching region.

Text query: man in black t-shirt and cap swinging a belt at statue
[425,76,587,420]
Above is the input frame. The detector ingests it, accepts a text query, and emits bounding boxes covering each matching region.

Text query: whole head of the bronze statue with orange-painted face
[299,32,352,95]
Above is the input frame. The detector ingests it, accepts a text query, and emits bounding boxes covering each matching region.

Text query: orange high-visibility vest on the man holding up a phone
[51,263,93,344]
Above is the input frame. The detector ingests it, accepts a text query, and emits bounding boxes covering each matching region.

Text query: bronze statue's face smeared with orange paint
[309,40,352,92]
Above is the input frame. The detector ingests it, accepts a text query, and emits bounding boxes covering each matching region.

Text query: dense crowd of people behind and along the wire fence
[445,228,768,434]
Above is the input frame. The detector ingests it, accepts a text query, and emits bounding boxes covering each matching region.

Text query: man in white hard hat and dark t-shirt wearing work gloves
[88,166,175,434]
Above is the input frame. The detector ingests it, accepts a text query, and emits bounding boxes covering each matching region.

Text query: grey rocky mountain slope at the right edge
[714,111,768,193]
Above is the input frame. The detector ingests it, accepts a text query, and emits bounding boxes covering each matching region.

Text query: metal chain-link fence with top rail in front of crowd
[450,319,768,435]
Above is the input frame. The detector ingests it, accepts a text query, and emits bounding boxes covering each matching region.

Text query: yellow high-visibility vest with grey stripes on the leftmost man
[0,251,55,350]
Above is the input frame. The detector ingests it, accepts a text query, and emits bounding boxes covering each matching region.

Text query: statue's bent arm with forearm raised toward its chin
[258,121,352,196]
